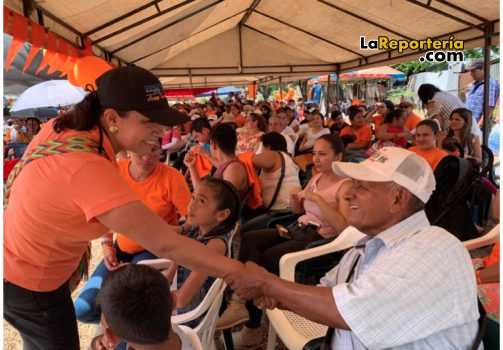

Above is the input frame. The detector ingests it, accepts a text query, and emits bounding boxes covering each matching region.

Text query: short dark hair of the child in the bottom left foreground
[97,264,173,345]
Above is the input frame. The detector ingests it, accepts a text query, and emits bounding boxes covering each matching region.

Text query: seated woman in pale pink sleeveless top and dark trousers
[217,134,351,346]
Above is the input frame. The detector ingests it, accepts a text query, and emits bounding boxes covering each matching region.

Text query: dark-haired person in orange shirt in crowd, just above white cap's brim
[340,106,372,158]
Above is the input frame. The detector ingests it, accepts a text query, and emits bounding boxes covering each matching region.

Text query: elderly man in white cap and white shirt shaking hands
[226,147,479,349]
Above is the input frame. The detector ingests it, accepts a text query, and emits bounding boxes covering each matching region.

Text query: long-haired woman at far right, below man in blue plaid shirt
[447,108,482,164]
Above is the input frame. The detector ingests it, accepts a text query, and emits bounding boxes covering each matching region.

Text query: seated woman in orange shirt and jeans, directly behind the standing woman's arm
[74,149,190,323]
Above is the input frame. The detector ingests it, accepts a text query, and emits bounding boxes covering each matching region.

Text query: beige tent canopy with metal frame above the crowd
[4,0,499,88]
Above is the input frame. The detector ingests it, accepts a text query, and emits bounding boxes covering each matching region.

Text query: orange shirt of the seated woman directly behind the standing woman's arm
[117,159,191,254]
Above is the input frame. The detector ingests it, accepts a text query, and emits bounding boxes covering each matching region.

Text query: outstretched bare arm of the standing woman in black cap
[96,201,243,277]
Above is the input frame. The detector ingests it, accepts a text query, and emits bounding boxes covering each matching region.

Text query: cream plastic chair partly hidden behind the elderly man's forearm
[267,227,365,350]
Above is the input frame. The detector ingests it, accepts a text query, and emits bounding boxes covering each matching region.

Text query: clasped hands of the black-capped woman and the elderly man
[224,261,283,310]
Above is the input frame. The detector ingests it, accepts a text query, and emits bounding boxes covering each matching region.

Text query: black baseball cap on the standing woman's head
[96,66,190,126]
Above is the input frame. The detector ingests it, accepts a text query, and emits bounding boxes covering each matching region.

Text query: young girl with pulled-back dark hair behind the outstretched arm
[167,177,241,318]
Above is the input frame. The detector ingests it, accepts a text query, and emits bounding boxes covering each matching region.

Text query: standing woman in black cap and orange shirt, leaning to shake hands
[3,66,244,350]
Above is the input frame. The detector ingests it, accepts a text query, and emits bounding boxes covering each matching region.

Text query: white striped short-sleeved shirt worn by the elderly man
[321,211,479,350]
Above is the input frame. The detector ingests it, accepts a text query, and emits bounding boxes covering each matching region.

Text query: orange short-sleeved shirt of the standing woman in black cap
[4,120,139,292]
